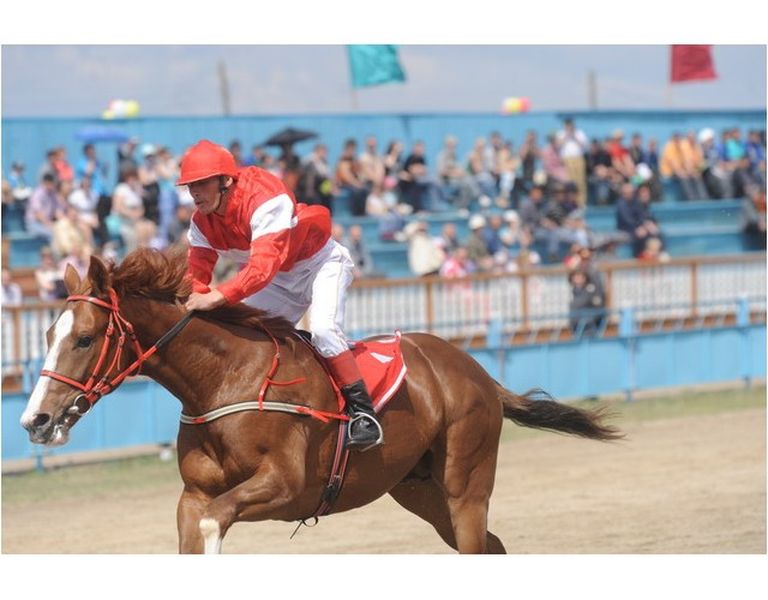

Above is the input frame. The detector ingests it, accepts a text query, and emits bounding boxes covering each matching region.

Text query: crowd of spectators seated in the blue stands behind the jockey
[3,119,766,299]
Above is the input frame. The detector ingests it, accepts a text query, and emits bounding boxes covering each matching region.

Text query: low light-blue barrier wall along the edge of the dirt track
[2,324,766,460]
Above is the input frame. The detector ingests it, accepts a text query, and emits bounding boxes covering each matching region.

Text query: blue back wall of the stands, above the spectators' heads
[2,110,765,183]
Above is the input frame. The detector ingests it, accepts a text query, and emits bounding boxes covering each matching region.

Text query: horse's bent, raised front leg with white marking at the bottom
[199,463,304,554]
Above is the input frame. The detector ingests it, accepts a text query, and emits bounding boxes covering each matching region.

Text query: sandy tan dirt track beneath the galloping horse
[3,409,766,554]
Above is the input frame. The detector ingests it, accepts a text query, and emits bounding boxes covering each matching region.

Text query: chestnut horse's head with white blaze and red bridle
[21,257,116,446]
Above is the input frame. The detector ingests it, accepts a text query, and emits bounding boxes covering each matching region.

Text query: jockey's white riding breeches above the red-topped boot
[243,239,354,358]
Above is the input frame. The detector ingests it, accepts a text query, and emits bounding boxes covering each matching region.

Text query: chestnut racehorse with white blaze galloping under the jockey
[21,250,619,553]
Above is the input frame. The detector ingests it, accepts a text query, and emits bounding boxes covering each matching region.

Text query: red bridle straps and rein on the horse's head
[40,289,194,417]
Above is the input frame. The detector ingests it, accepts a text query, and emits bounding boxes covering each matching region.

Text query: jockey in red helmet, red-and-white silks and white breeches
[177,140,383,450]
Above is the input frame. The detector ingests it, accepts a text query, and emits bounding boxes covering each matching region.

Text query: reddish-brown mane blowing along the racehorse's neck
[110,248,295,339]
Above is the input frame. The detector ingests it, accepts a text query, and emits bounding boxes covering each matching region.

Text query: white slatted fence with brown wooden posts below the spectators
[2,255,766,376]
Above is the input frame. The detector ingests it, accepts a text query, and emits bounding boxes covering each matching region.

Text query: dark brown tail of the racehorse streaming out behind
[498,385,624,440]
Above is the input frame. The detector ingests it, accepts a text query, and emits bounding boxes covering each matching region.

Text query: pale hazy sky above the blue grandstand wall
[2,44,766,118]
